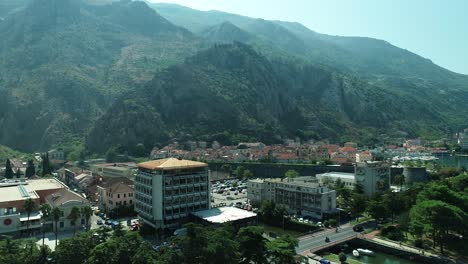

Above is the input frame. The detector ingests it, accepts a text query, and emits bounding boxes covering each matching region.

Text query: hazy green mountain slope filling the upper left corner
[0,0,197,151]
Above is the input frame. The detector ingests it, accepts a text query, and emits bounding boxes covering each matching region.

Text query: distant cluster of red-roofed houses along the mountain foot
[150,136,450,165]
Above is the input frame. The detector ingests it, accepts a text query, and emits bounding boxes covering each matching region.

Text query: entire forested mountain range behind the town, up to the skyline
[0,0,468,155]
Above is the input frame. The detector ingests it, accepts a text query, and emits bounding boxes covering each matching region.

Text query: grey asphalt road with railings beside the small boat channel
[296,225,357,254]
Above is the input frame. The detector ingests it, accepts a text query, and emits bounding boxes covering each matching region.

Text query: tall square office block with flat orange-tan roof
[135,158,210,228]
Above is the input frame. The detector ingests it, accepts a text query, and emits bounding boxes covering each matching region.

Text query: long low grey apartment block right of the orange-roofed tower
[247,177,336,219]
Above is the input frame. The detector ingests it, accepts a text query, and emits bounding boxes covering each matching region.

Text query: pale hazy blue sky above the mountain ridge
[149,0,468,74]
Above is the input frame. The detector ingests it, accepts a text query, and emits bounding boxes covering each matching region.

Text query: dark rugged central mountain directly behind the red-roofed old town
[87,43,456,153]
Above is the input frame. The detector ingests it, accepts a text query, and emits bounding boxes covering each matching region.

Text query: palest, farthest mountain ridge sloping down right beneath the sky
[151,4,468,128]
